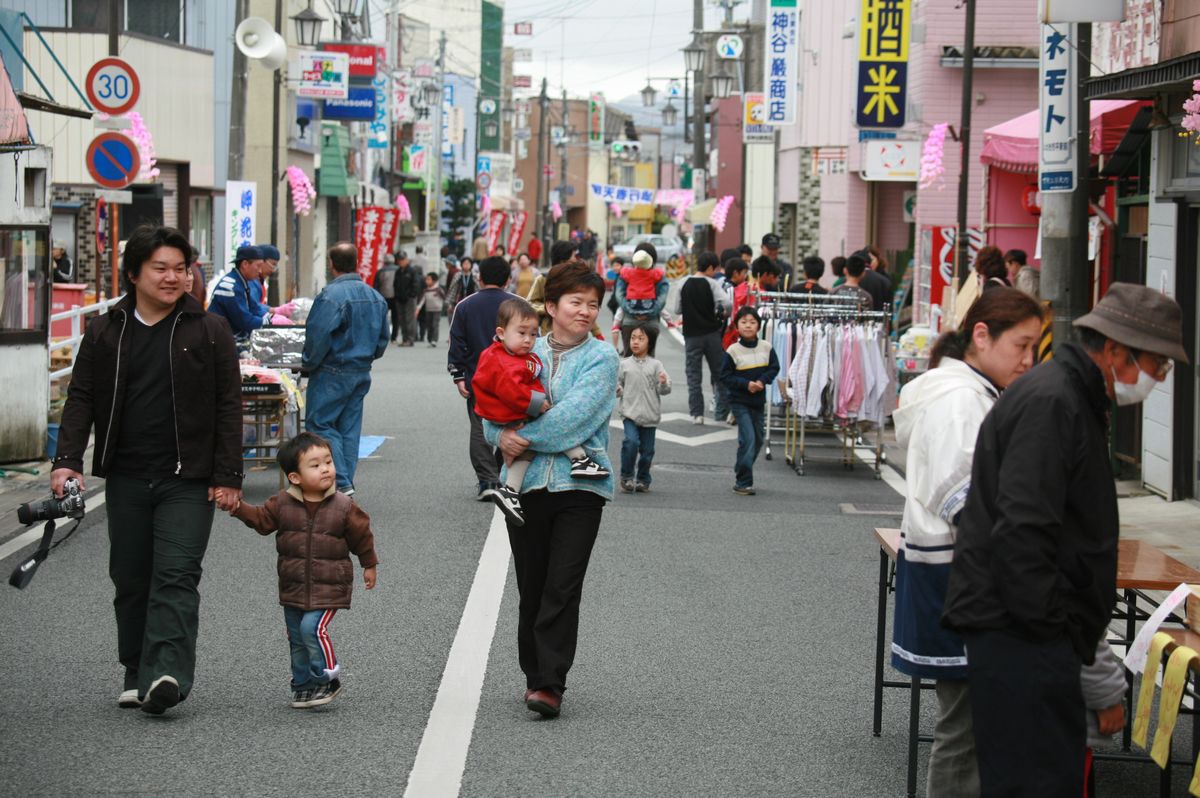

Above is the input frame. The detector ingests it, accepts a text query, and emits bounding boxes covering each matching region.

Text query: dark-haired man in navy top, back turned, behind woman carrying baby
[446,258,512,502]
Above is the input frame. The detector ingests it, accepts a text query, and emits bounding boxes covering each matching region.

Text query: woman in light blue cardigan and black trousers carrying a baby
[486,262,618,718]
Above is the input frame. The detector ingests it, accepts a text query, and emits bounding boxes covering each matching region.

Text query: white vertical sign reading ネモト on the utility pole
[1038,24,1076,192]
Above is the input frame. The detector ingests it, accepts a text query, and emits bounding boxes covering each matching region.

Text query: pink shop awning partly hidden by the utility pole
[979,100,1150,173]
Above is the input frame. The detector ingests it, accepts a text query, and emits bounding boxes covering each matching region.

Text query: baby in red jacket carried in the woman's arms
[470,298,608,527]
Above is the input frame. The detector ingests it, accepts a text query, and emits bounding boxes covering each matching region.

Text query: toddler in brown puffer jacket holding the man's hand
[230,432,379,709]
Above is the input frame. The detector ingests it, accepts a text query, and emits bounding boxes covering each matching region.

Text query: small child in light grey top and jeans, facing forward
[617,324,671,493]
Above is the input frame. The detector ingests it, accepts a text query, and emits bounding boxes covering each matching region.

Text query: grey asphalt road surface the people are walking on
[0,314,1190,797]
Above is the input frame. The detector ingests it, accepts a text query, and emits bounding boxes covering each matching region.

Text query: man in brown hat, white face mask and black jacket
[942,283,1188,796]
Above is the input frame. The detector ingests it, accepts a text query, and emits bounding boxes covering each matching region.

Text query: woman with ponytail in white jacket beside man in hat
[892,288,1043,798]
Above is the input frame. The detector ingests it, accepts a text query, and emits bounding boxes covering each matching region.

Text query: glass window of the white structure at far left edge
[0,228,50,340]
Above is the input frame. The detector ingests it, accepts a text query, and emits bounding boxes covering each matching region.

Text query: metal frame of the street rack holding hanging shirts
[754,292,892,479]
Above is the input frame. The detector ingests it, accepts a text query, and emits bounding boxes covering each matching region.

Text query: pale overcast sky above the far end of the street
[504,0,724,104]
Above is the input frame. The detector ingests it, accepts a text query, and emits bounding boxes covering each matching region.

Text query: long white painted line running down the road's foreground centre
[404,508,509,798]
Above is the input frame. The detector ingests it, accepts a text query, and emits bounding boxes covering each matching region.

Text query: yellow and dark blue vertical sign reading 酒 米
[854,0,912,127]
